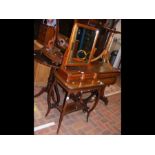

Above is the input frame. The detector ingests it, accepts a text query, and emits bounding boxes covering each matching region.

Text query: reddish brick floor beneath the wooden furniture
[34,83,121,135]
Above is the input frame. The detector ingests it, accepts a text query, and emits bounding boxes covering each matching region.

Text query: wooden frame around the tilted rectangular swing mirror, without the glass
[61,23,99,67]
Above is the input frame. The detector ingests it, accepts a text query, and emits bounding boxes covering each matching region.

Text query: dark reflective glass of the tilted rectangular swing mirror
[69,27,96,64]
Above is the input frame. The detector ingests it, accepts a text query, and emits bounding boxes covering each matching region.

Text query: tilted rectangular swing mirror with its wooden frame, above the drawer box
[62,23,99,66]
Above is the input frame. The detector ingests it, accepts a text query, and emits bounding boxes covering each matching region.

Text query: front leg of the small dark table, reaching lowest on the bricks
[57,92,68,134]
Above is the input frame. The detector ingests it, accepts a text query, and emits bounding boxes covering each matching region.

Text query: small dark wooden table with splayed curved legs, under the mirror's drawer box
[46,72,104,134]
